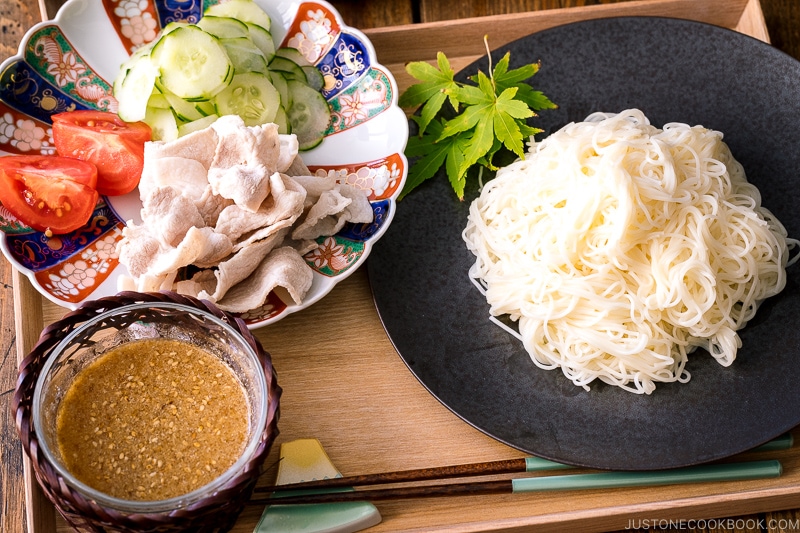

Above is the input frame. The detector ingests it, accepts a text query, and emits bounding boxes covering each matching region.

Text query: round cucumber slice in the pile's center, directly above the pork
[214,72,282,126]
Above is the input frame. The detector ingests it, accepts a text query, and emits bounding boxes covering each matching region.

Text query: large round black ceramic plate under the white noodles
[368,17,800,470]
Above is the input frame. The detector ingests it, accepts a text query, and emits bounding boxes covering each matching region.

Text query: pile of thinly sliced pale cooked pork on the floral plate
[118,115,373,313]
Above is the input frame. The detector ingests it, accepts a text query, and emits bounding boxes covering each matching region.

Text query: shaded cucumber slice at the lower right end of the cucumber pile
[286,80,331,150]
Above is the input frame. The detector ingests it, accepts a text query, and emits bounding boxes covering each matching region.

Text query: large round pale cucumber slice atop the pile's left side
[151,25,233,101]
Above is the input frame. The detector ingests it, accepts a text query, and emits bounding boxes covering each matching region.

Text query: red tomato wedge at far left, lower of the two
[0,155,99,233]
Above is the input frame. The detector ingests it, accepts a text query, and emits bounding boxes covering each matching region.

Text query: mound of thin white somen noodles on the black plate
[463,109,797,394]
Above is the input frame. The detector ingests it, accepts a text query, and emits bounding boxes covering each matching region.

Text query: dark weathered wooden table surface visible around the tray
[0,0,800,533]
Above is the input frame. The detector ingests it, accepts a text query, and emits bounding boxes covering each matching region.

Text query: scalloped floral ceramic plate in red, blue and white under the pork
[0,0,408,328]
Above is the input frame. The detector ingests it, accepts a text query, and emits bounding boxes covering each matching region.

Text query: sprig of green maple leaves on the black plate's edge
[399,36,556,200]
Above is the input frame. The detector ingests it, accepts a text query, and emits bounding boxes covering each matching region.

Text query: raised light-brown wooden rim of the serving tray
[13,0,798,533]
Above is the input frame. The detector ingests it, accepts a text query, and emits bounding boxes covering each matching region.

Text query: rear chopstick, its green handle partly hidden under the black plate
[255,433,793,493]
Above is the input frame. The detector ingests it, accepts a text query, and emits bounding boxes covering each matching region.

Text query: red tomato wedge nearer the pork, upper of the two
[52,110,152,196]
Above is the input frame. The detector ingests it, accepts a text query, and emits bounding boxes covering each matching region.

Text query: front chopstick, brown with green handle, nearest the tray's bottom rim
[251,460,782,505]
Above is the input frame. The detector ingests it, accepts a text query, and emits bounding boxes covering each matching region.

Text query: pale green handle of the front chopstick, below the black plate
[512,460,783,492]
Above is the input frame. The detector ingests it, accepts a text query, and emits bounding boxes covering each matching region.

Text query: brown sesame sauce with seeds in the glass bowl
[56,339,249,501]
